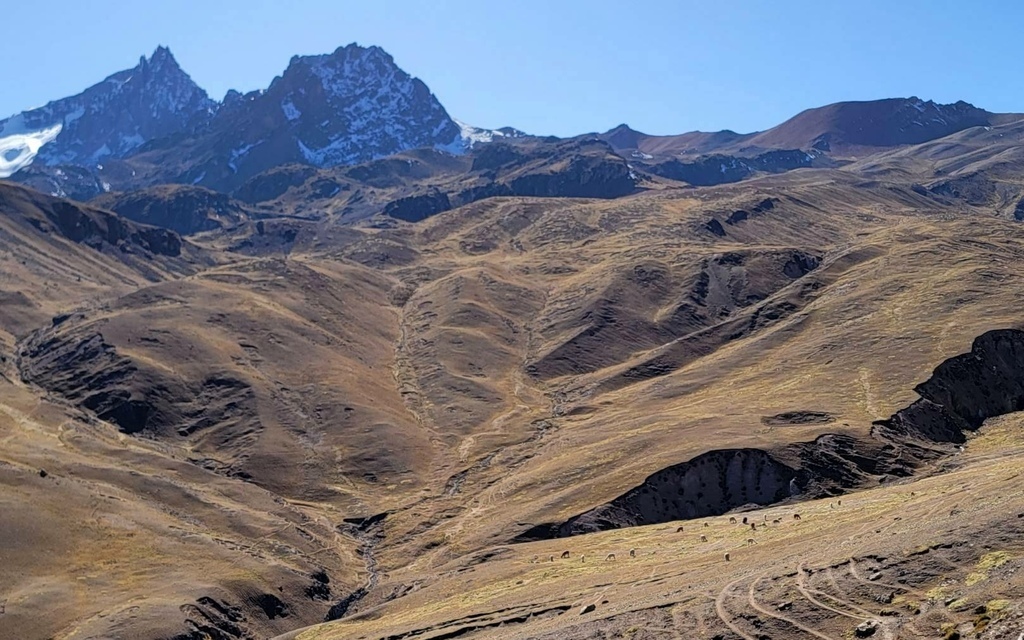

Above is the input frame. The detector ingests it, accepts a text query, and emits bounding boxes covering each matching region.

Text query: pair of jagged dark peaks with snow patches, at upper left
[0,43,512,197]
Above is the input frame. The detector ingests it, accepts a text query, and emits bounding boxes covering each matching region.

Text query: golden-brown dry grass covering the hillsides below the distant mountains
[0,165,1024,639]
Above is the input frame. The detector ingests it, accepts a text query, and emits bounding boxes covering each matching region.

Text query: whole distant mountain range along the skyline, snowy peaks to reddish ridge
[0,44,1021,211]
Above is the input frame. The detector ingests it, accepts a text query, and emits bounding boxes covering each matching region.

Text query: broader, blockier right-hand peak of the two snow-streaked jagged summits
[169,44,465,189]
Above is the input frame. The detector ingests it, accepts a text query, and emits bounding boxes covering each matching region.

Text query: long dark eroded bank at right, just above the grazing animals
[517,329,1024,541]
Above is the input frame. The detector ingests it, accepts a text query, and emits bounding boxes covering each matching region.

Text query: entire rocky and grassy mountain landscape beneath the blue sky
[6,39,1024,640]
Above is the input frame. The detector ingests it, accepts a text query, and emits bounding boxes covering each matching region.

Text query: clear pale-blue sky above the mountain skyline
[0,0,1024,135]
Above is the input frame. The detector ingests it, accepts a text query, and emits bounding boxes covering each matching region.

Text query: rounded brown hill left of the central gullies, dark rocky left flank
[23,252,430,509]
